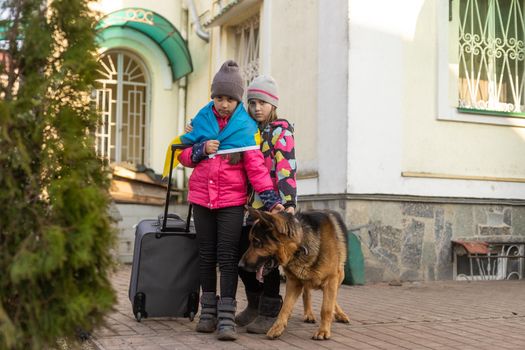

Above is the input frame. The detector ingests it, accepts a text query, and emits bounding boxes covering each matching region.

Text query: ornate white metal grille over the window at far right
[458,0,525,113]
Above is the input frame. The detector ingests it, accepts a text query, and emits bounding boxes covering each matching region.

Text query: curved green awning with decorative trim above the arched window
[97,8,193,81]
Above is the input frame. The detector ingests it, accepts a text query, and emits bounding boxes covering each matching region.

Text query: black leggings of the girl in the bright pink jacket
[193,205,244,298]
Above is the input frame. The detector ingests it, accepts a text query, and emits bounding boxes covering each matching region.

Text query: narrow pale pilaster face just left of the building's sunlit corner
[316,0,349,194]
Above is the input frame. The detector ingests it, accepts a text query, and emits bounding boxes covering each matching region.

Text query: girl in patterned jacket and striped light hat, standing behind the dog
[235,76,297,334]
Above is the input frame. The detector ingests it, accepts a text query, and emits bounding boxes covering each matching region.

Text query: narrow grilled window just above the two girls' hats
[234,14,259,86]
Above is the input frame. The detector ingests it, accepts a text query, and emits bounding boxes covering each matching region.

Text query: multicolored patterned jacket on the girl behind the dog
[248,119,297,209]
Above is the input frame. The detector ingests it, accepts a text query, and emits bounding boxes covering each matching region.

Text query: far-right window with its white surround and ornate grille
[437,0,525,127]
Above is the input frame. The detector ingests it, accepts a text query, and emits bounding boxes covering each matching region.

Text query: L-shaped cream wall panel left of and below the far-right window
[402,1,525,181]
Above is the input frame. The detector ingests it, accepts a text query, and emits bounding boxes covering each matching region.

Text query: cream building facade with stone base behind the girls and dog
[95,0,525,282]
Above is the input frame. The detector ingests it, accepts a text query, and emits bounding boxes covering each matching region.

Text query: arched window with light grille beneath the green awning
[96,51,149,165]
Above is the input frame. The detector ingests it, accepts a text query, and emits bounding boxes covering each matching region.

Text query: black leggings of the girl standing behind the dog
[239,226,281,298]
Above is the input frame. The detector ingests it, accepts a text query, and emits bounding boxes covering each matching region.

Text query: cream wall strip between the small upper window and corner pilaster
[270,0,320,173]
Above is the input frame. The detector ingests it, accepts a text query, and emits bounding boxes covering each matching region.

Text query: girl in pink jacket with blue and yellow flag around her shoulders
[178,61,284,340]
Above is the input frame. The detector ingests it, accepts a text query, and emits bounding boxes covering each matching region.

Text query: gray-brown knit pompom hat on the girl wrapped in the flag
[211,60,244,101]
